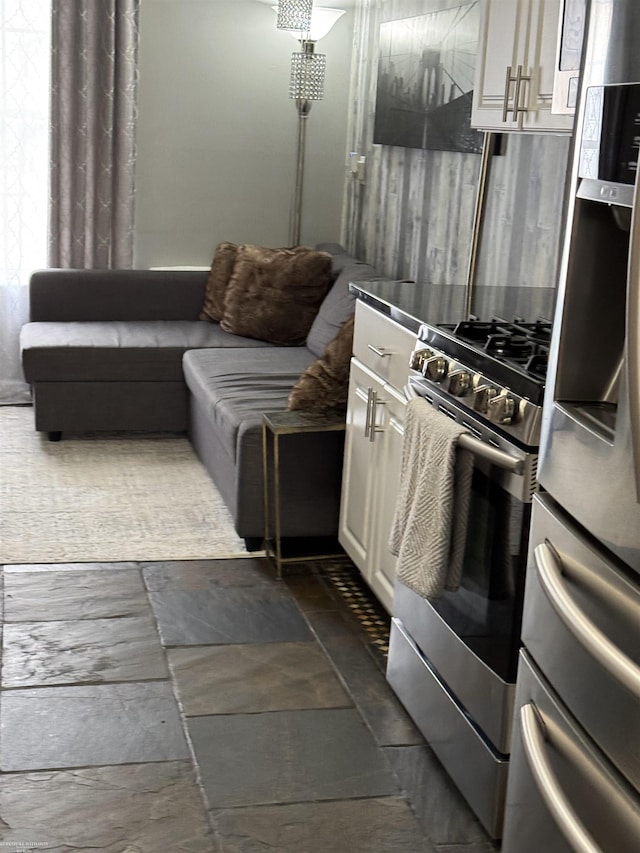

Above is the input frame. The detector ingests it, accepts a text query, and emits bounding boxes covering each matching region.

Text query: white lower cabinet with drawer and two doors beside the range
[339,302,416,612]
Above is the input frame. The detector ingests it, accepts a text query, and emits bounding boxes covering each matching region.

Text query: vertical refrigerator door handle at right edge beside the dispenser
[625,181,640,503]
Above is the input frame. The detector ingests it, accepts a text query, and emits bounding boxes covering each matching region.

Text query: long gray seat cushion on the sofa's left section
[20,320,266,382]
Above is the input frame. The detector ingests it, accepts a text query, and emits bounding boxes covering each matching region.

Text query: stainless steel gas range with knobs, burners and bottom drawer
[387,320,551,838]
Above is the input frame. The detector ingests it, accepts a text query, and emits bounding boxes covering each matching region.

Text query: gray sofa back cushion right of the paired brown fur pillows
[307,255,382,357]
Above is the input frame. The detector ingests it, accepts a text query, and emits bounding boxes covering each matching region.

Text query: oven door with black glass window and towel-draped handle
[393,382,536,753]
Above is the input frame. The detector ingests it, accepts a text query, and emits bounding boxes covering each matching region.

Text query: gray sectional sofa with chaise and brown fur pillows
[21,244,380,547]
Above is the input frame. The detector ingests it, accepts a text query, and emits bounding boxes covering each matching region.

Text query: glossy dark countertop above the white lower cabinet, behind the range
[349,280,555,332]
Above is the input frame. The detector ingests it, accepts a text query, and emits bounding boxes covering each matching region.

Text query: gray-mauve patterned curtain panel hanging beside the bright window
[49,0,140,269]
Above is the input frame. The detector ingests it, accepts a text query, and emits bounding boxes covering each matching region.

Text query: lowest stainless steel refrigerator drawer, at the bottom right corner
[502,652,640,853]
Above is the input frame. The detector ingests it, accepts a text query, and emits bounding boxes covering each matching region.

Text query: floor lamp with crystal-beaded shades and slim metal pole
[272,5,344,246]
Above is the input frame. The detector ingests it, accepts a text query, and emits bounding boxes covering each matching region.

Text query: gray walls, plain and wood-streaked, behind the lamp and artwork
[135,0,569,320]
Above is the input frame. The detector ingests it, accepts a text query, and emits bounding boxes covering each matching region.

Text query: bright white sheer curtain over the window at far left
[0,0,51,404]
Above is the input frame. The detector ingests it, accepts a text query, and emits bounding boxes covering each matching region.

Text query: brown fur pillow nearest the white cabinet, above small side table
[287,317,354,414]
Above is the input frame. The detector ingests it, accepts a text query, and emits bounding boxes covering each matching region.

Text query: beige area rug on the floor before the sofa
[0,407,247,564]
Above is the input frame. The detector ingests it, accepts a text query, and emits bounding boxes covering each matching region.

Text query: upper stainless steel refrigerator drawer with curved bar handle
[522,495,640,790]
